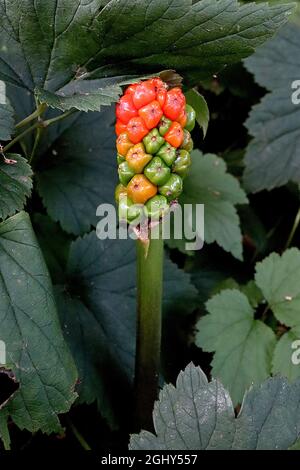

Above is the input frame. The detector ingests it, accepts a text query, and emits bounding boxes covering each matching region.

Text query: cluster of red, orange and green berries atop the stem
[116,78,195,222]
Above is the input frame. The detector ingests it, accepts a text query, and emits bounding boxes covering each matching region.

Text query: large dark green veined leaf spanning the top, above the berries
[0,0,292,109]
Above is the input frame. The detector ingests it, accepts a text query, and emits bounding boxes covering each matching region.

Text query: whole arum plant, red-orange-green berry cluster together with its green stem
[115,77,196,428]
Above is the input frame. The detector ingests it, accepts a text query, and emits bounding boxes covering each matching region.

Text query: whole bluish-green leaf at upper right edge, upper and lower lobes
[244,25,300,192]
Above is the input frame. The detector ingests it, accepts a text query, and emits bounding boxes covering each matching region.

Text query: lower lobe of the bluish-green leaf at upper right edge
[244,88,300,192]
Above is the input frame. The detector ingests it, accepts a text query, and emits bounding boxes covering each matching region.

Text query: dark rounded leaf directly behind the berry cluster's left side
[37,110,117,235]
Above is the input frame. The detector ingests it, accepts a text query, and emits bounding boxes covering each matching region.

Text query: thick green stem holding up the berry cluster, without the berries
[135,239,164,430]
